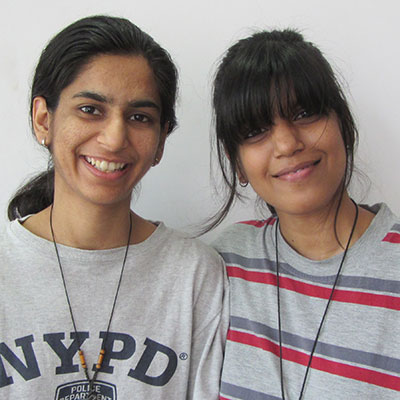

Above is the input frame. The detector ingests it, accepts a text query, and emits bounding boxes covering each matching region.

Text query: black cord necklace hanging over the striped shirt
[275,199,358,400]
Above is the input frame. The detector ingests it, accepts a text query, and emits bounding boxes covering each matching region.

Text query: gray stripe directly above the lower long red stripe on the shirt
[230,316,400,373]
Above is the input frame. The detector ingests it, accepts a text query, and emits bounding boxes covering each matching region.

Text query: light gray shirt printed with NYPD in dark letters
[0,221,228,400]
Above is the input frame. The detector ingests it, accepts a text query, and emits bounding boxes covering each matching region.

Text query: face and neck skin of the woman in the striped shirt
[239,110,373,260]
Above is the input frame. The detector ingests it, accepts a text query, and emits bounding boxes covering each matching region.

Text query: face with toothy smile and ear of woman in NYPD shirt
[33,55,167,211]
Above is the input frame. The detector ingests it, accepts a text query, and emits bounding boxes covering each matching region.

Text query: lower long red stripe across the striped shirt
[228,330,400,391]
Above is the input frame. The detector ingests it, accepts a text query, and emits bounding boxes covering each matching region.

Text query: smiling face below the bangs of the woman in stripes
[238,111,346,219]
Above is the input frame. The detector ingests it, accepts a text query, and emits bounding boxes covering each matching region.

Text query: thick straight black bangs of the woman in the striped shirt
[214,34,338,145]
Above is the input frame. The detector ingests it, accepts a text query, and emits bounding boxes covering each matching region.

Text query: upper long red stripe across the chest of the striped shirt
[227,266,400,311]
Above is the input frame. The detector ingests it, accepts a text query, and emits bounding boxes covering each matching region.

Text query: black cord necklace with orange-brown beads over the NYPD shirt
[50,205,132,400]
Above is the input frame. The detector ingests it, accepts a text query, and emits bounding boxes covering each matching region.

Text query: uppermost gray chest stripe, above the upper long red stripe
[221,253,400,294]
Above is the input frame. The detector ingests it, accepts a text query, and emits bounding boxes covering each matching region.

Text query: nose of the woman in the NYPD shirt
[97,115,128,152]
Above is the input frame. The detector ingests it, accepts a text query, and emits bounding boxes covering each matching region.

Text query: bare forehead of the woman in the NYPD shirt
[61,54,160,104]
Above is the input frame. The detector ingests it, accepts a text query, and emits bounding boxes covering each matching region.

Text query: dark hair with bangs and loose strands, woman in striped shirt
[209,30,357,228]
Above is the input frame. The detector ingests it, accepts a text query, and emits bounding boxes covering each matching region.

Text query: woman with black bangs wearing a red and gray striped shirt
[213,30,400,400]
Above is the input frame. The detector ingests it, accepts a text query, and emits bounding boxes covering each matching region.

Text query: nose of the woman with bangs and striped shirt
[272,119,304,157]
